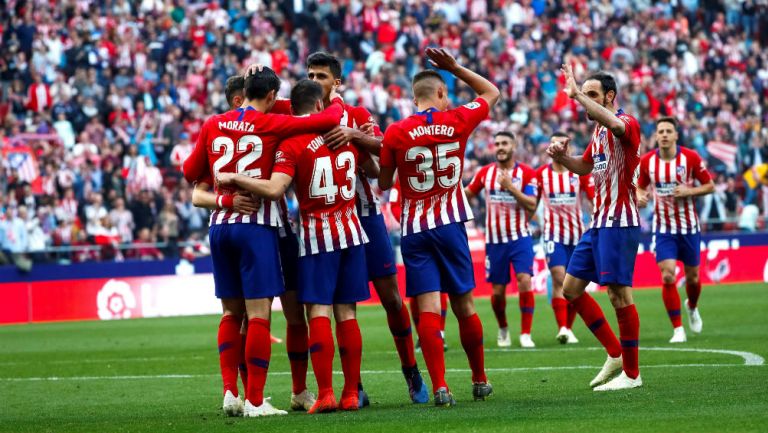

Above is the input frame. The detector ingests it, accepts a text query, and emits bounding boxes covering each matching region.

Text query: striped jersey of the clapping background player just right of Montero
[467,162,538,244]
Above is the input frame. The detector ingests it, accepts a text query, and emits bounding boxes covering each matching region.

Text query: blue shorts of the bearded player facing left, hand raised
[567,227,640,286]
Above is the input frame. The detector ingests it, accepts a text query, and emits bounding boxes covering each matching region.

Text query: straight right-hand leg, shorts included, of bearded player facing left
[595,227,643,391]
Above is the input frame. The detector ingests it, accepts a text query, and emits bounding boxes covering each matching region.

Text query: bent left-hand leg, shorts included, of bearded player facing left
[563,229,622,387]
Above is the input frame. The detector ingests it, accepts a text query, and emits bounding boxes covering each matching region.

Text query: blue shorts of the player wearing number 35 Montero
[400,223,475,297]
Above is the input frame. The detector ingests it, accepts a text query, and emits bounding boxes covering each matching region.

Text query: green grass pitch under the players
[0,284,768,433]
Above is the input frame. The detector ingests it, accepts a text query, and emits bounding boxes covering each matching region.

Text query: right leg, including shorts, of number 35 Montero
[436,224,488,400]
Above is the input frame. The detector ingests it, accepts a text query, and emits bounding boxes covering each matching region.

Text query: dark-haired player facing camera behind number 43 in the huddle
[268,52,429,407]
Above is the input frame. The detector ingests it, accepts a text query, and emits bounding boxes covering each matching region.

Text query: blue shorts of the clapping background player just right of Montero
[485,236,533,285]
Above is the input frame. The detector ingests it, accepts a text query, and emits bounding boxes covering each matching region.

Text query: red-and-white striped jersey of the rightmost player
[638,146,712,234]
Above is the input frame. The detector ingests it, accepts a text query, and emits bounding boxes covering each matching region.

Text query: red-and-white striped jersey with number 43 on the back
[273,134,368,256]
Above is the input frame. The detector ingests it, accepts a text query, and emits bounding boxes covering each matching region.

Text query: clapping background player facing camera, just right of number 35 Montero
[464,131,538,348]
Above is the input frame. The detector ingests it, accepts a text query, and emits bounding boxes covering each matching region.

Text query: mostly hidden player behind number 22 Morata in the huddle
[192,75,315,410]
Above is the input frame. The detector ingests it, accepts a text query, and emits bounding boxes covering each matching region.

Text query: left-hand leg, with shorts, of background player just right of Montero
[485,244,512,347]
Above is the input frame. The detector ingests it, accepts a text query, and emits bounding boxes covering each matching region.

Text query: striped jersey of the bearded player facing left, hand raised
[582,110,640,228]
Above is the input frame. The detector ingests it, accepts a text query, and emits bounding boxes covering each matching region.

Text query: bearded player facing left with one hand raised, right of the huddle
[547,65,643,391]
